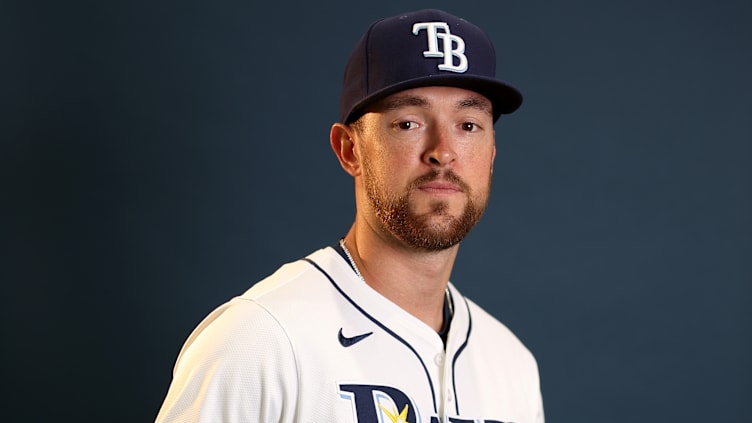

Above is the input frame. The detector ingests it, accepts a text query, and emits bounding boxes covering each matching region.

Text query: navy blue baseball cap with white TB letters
[340,9,522,123]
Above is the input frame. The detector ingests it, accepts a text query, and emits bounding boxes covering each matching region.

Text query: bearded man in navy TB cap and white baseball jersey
[157,10,543,423]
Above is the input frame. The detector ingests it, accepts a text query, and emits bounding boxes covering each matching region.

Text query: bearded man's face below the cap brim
[356,87,496,251]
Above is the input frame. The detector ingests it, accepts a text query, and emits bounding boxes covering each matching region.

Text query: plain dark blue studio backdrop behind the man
[0,0,752,423]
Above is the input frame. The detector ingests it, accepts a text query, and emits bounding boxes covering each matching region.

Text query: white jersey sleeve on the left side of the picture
[156,298,298,423]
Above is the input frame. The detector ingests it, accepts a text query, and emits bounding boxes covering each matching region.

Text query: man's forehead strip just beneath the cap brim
[370,86,492,115]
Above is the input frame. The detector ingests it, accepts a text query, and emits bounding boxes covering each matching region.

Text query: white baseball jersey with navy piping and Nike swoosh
[157,247,543,423]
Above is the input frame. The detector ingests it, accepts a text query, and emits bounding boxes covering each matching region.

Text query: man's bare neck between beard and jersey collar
[345,225,458,331]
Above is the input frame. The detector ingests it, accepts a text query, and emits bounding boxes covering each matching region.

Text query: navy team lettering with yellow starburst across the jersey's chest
[339,384,512,423]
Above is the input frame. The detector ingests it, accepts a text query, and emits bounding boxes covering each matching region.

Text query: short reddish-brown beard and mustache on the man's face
[363,166,491,251]
